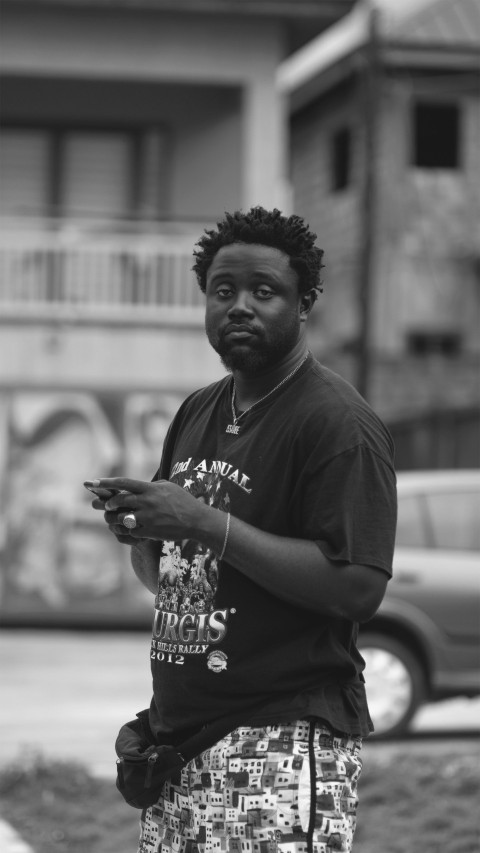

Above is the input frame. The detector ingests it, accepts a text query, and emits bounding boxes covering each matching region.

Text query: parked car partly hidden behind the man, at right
[359,470,480,737]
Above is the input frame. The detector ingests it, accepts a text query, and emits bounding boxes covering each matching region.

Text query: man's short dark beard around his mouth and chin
[205,313,299,374]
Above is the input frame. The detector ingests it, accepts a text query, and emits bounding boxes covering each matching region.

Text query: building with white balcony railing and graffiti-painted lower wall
[0,0,352,624]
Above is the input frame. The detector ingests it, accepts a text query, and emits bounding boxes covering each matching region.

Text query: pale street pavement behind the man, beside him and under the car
[0,629,480,853]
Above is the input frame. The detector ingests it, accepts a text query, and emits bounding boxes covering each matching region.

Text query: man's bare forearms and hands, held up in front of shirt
[115,478,388,622]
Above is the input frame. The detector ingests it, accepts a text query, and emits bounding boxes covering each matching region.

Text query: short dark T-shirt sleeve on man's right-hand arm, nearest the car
[292,445,397,576]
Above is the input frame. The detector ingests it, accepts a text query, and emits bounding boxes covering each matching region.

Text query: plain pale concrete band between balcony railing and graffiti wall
[0,323,225,396]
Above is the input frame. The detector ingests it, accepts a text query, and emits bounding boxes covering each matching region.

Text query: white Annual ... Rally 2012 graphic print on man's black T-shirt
[151,457,252,673]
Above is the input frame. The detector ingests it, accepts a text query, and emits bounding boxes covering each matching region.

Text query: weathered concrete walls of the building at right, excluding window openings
[291,64,480,419]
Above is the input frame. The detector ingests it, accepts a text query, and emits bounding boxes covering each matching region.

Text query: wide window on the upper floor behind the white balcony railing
[0,127,167,220]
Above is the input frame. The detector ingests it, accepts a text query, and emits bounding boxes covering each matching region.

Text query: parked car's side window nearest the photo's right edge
[426,491,480,551]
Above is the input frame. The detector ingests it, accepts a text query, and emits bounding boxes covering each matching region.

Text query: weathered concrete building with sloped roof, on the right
[278,0,480,440]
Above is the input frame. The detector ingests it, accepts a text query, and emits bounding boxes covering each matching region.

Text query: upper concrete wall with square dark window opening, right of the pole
[372,73,480,353]
